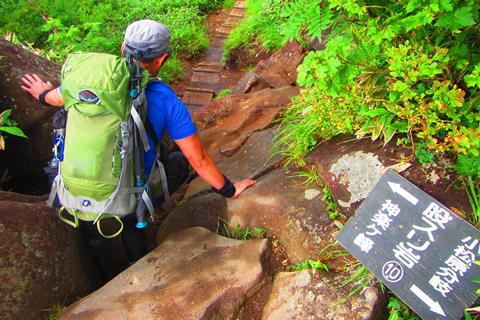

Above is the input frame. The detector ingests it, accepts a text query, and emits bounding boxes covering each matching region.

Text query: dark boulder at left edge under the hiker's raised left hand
[0,40,60,194]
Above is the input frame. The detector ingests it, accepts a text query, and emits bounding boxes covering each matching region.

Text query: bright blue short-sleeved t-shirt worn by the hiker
[145,81,197,175]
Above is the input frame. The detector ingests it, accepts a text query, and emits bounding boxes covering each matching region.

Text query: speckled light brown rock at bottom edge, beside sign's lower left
[262,270,385,320]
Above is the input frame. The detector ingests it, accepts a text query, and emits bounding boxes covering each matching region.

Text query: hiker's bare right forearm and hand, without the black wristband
[175,134,256,198]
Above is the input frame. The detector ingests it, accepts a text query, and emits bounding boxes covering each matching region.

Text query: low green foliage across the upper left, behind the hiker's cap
[0,0,229,81]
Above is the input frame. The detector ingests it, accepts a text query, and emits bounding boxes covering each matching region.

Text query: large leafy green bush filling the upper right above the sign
[251,0,480,165]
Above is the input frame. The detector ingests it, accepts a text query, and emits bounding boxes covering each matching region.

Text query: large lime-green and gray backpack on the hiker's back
[49,52,168,238]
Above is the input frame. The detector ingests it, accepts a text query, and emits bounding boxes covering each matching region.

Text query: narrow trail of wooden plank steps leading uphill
[182,0,245,111]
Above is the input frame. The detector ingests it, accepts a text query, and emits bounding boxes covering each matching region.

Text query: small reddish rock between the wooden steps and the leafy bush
[255,41,305,88]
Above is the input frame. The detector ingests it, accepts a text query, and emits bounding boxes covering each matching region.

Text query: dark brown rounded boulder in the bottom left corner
[0,193,98,320]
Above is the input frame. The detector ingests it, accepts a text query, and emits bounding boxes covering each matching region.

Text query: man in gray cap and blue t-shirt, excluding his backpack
[21,20,255,261]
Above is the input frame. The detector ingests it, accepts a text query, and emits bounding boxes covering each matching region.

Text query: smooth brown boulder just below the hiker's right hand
[157,169,338,262]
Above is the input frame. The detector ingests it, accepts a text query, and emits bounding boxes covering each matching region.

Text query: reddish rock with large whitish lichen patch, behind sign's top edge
[308,136,468,215]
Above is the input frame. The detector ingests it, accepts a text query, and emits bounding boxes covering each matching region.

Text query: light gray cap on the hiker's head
[124,20,170,59]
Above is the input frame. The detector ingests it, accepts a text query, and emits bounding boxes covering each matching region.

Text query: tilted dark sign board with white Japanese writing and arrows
[337,170,480,320]
